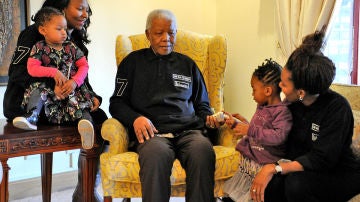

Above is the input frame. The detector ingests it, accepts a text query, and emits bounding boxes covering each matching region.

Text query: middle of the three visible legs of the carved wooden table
[41,152,53,202]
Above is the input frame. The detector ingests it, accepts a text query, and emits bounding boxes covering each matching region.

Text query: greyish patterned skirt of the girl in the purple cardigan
[224,154,263,202]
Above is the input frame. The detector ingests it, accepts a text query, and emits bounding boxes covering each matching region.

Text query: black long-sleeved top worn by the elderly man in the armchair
[110,48,212,138]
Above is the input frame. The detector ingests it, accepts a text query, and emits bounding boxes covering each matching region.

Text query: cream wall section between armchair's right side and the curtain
[216,0,276,119]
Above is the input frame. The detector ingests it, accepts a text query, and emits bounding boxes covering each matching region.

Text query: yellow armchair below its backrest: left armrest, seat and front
[100,118,240,198]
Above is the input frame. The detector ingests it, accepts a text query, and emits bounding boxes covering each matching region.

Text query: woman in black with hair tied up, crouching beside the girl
[251,28,360,202]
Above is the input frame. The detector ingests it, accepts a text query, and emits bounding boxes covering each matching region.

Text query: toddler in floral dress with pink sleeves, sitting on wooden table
[13,7,95,149]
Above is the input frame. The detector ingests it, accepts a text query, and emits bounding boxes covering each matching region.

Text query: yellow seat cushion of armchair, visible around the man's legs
[101,146,239,185]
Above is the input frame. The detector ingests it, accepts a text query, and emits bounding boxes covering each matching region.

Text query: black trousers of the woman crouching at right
[265,171,360,202]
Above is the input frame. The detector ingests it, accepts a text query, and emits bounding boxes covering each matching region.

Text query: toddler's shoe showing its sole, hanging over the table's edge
[78,119,95,149]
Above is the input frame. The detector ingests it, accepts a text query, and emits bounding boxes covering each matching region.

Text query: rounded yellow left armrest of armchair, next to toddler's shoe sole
[101,118,129,155]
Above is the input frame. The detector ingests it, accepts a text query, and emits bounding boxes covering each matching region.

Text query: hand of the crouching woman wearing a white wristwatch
[250,164,276,202]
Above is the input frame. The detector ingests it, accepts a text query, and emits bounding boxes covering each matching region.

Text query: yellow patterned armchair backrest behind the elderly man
[115,30,227,112]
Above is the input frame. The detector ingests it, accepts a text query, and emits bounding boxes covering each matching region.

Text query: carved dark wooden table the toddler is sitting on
[0,119,99,202]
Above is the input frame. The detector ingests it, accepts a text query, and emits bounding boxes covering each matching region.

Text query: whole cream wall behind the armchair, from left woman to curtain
[0,0,275,118]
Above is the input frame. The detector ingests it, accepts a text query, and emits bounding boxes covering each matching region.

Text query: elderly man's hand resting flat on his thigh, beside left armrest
[133,116,158,143]
